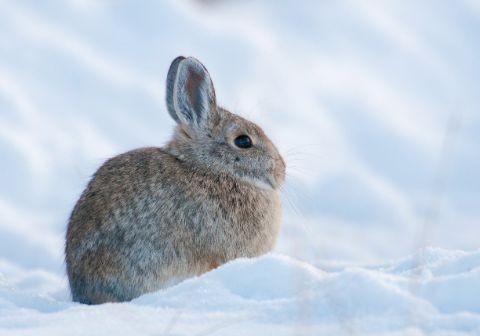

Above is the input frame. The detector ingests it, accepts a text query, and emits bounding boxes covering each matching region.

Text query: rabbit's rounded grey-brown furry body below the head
[66,148,280,303]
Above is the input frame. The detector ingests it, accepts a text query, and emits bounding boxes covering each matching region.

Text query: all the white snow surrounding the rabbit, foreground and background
[0,0,480,335]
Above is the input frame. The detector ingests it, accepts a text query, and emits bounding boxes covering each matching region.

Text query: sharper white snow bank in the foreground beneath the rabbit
[0,248,480,335]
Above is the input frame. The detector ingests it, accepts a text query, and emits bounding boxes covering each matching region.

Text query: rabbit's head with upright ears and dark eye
[166,57,285,189]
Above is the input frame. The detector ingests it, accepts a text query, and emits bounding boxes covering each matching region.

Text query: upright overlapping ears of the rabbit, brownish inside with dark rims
[167,56,217,131]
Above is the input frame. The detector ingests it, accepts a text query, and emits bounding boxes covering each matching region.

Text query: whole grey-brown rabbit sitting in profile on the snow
[65,56,286,304]
